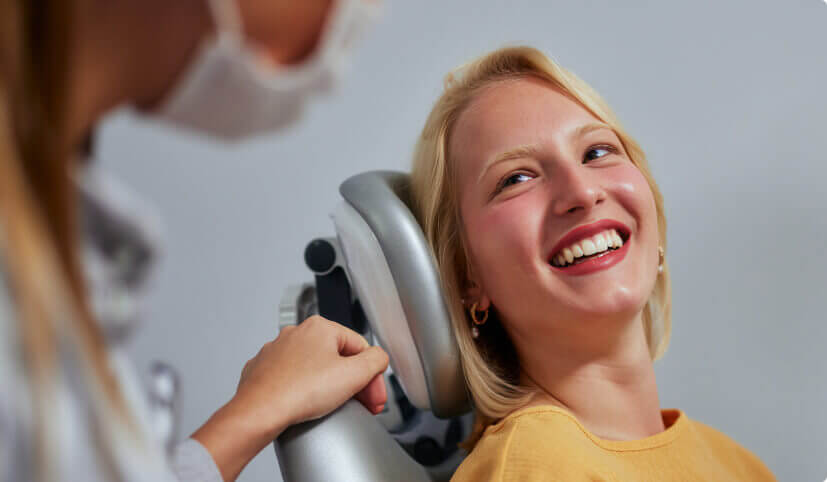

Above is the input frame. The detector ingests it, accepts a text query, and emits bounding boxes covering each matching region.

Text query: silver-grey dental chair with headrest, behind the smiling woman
[273,171,472,482]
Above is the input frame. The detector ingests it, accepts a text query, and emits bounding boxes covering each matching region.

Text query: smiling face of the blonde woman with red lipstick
[450,78,659,345]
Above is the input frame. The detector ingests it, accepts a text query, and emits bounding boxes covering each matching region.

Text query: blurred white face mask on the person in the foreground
[154,0,378,140]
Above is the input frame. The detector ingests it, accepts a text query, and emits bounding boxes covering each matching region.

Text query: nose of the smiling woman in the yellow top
[550,163,606,216]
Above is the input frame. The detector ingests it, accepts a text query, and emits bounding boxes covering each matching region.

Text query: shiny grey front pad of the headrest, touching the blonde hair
[339,171,469,418]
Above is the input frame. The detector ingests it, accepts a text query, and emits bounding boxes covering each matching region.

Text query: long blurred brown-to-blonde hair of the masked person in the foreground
[0,0,140,480]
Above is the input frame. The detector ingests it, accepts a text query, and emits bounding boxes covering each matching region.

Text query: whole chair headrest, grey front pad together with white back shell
[333,171,469,418]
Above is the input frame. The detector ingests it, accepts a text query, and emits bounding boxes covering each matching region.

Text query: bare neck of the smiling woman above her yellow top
[515,317,664,440]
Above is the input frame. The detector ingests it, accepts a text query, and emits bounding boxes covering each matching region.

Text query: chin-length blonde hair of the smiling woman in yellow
[411,47,671,449]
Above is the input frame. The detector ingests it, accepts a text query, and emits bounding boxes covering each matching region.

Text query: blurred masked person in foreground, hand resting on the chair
[0,0,388,482]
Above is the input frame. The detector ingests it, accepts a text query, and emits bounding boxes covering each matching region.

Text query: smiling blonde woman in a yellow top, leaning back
[412,47,774,480]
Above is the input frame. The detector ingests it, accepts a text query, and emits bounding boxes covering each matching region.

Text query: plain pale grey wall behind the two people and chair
[99,0,827,481]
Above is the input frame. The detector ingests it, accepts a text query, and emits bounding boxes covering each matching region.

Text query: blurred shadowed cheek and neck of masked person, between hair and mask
[69,0,212,150]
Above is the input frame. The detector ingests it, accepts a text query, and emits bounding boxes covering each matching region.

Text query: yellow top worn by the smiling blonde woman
[451,405,775,482]
